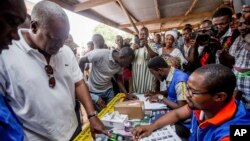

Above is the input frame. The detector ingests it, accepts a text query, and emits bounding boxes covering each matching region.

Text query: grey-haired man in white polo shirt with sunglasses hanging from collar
[2,1,108,141]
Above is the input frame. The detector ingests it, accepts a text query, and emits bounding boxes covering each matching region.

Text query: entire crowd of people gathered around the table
[0,0,250,141]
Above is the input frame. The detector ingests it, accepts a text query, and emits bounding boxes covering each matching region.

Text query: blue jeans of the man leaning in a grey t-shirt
[90,88,114,112]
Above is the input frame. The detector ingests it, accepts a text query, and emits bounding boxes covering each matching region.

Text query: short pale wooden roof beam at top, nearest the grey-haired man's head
[72,0,116,12]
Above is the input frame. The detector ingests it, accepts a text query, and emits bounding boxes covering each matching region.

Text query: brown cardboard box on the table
[115,101,144,119]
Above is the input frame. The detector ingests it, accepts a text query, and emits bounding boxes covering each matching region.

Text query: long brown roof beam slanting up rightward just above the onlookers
[119,12,212,29]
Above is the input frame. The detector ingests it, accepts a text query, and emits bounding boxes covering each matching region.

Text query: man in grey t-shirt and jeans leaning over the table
[79,47,136,112]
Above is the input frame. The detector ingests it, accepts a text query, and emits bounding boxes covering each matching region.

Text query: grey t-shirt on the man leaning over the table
[86,49,122,93]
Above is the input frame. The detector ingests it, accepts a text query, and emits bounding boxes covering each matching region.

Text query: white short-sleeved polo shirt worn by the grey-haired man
[1,29,83,141]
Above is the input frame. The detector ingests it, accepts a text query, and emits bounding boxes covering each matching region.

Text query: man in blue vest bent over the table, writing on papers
[145,56,190,139]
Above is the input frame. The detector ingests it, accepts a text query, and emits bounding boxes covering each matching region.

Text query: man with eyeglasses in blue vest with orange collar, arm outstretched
[133,64,250,141]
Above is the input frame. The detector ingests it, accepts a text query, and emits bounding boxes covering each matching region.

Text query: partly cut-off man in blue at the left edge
[0,0,26,141]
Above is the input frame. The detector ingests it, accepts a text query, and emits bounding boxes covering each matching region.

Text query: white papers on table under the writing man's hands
[135,94,167,110]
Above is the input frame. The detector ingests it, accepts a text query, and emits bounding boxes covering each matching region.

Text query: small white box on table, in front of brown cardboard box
[102,112,128,129]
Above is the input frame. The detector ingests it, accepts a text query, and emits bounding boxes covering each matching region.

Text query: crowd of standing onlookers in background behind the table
[81,3,250,112]
